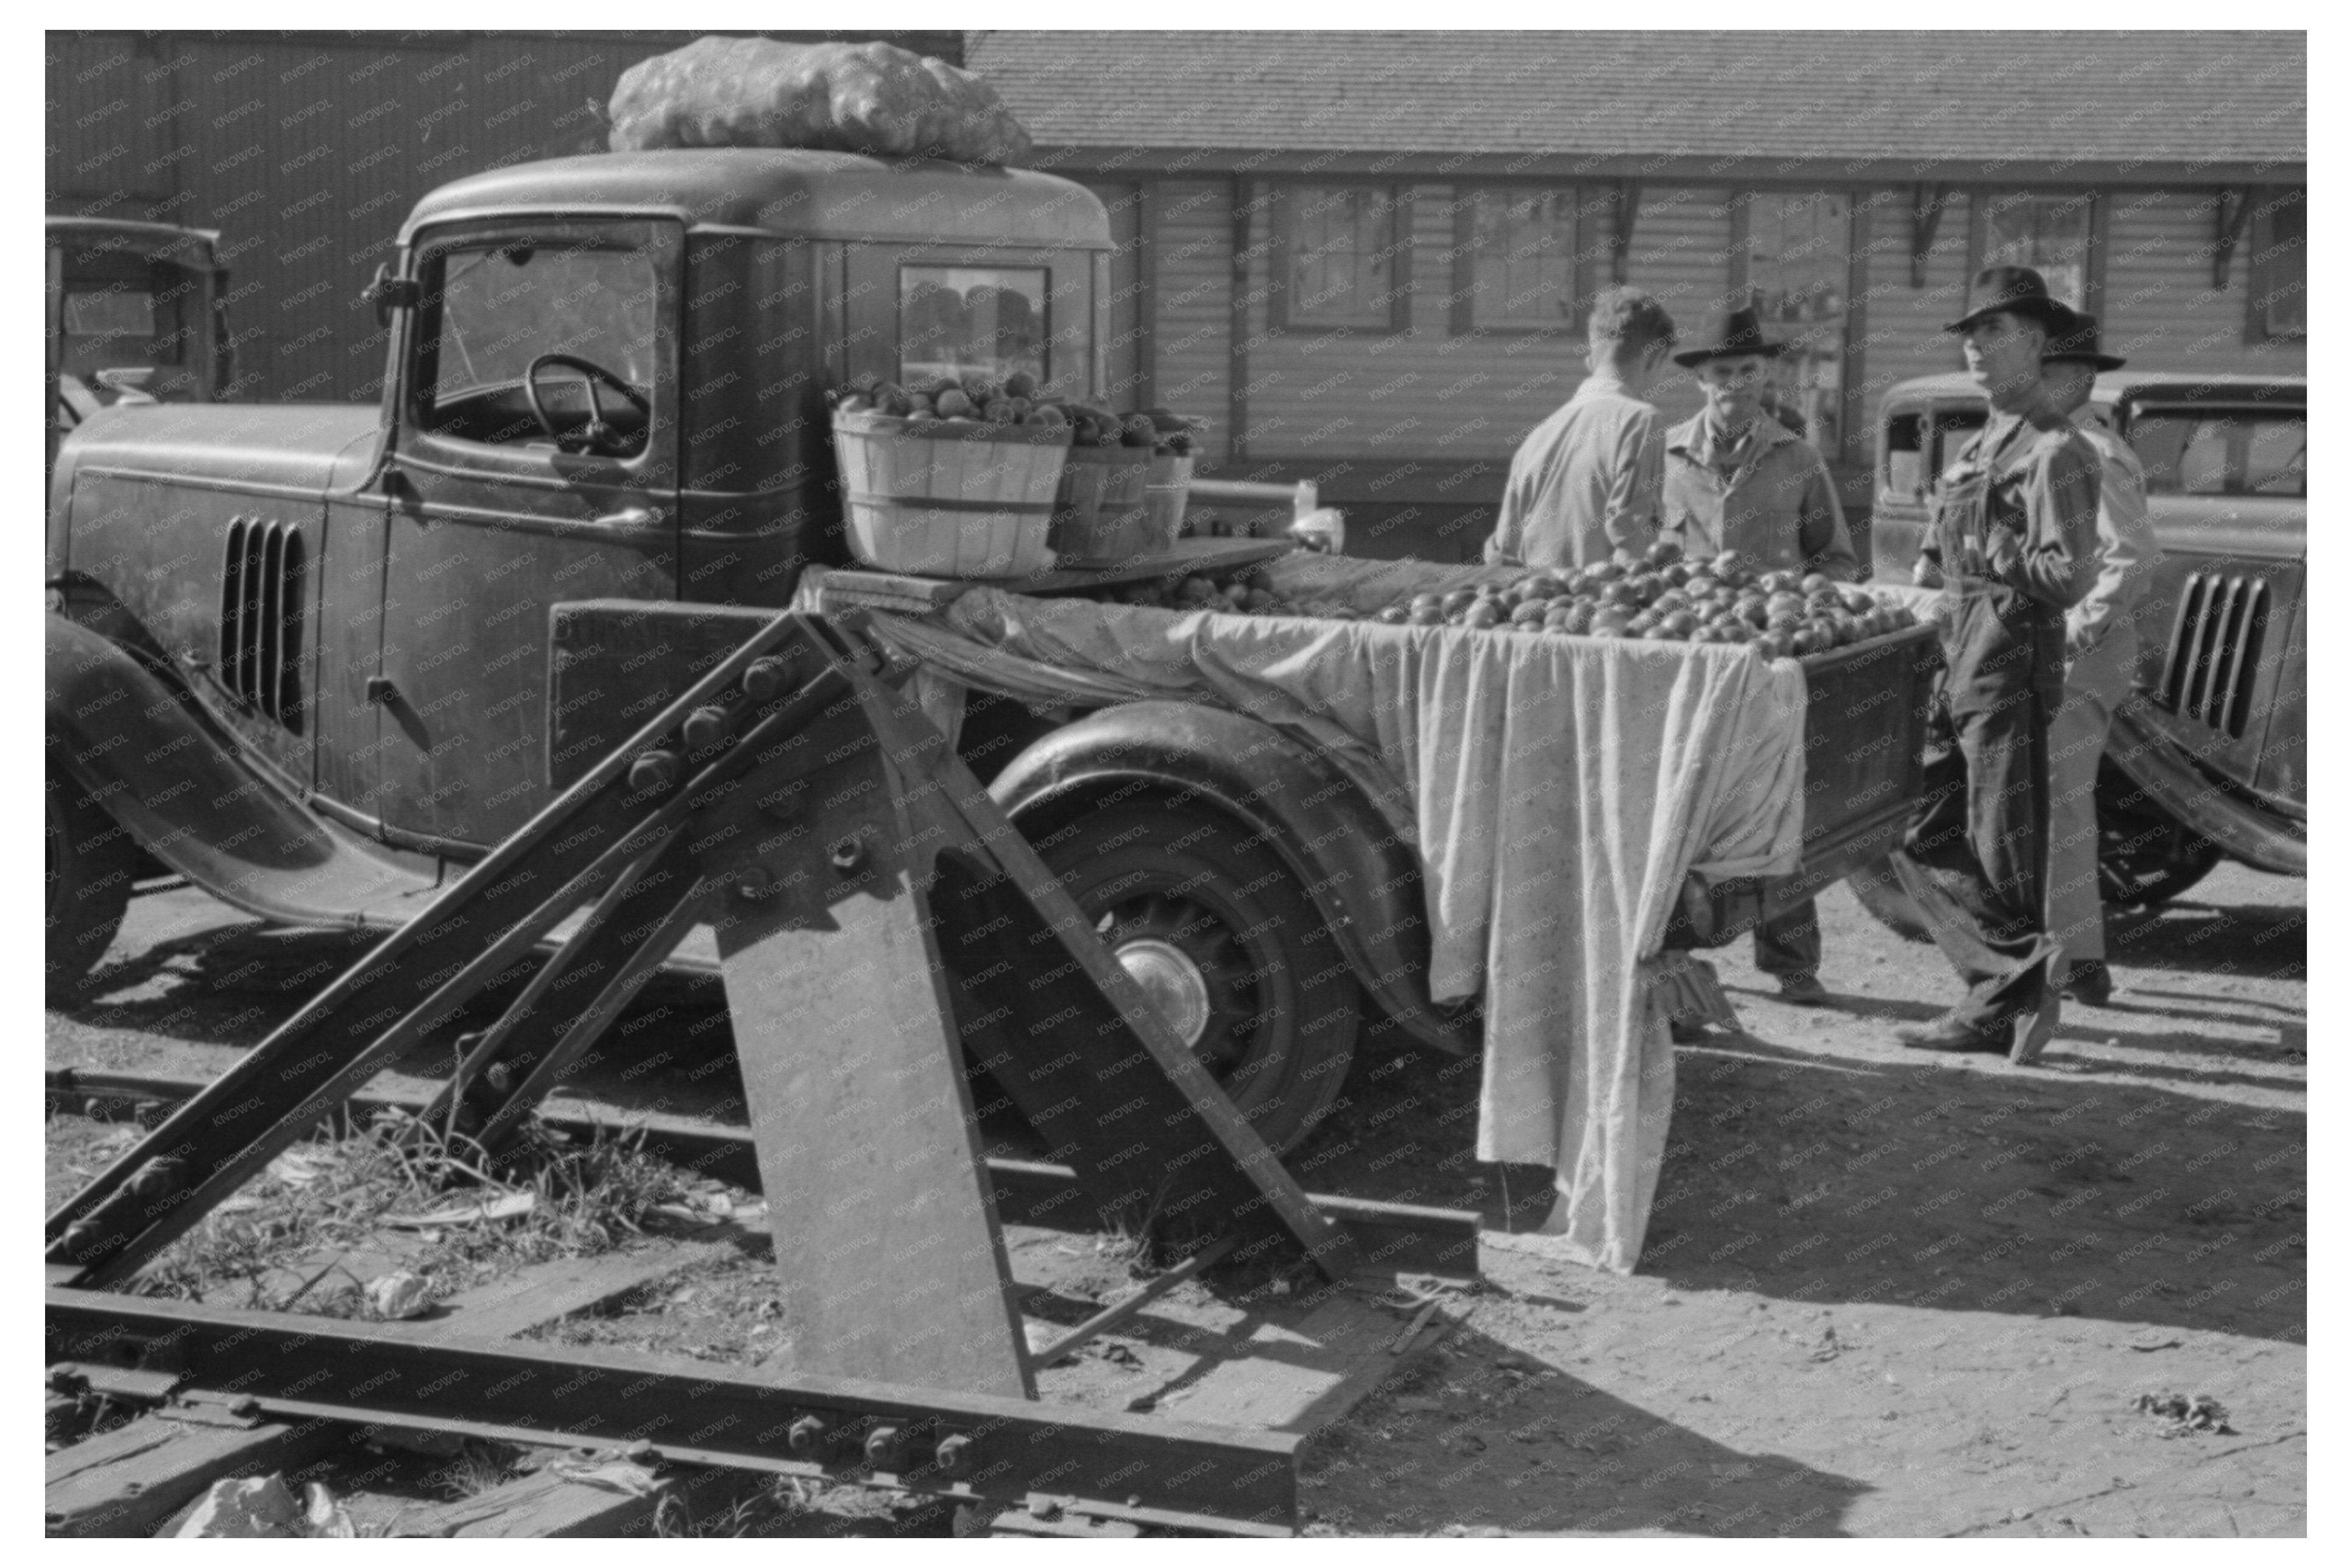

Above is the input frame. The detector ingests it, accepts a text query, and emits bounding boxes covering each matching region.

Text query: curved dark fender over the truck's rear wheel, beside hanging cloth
[988,703,1480,1056]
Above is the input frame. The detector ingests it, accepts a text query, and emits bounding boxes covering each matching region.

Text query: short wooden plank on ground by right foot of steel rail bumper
[1155,1291,1432,1432]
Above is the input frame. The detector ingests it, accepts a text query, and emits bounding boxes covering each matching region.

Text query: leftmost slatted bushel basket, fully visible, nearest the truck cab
[833,414,1070,578]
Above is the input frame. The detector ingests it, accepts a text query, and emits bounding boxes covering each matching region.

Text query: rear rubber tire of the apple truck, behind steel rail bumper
[1044,802,1364,1154]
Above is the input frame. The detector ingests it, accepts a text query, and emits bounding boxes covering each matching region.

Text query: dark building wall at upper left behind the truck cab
[47,30,962,402]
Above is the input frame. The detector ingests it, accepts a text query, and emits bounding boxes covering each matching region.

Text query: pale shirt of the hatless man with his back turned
[1486,372,1665,567]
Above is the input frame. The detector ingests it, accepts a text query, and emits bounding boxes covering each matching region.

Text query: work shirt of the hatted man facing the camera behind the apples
[1665,414,1856,583]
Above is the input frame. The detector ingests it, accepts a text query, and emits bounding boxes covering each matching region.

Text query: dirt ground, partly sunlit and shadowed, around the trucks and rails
[47,867,2308,1535]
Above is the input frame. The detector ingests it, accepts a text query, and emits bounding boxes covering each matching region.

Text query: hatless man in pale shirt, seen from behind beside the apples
[1486,289,1675,567]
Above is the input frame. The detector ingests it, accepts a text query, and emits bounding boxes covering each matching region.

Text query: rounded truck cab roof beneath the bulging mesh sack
[400,148,1110,249]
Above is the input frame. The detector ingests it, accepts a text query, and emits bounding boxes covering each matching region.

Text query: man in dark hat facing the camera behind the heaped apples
[1663,308,1856,1006]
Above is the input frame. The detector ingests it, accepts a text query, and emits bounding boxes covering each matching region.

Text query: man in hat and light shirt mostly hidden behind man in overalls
[2041,313,2164,1006]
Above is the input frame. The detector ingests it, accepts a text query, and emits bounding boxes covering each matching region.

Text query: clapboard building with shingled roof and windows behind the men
[964,33,2305,559]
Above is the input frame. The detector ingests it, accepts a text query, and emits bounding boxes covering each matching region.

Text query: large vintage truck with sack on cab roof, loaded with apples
[47,148,1917,1147]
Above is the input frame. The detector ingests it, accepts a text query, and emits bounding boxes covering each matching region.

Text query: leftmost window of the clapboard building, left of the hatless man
[1273,186,1411,331]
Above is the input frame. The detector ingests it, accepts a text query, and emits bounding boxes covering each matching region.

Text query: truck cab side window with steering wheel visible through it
[416,242,656,456]
